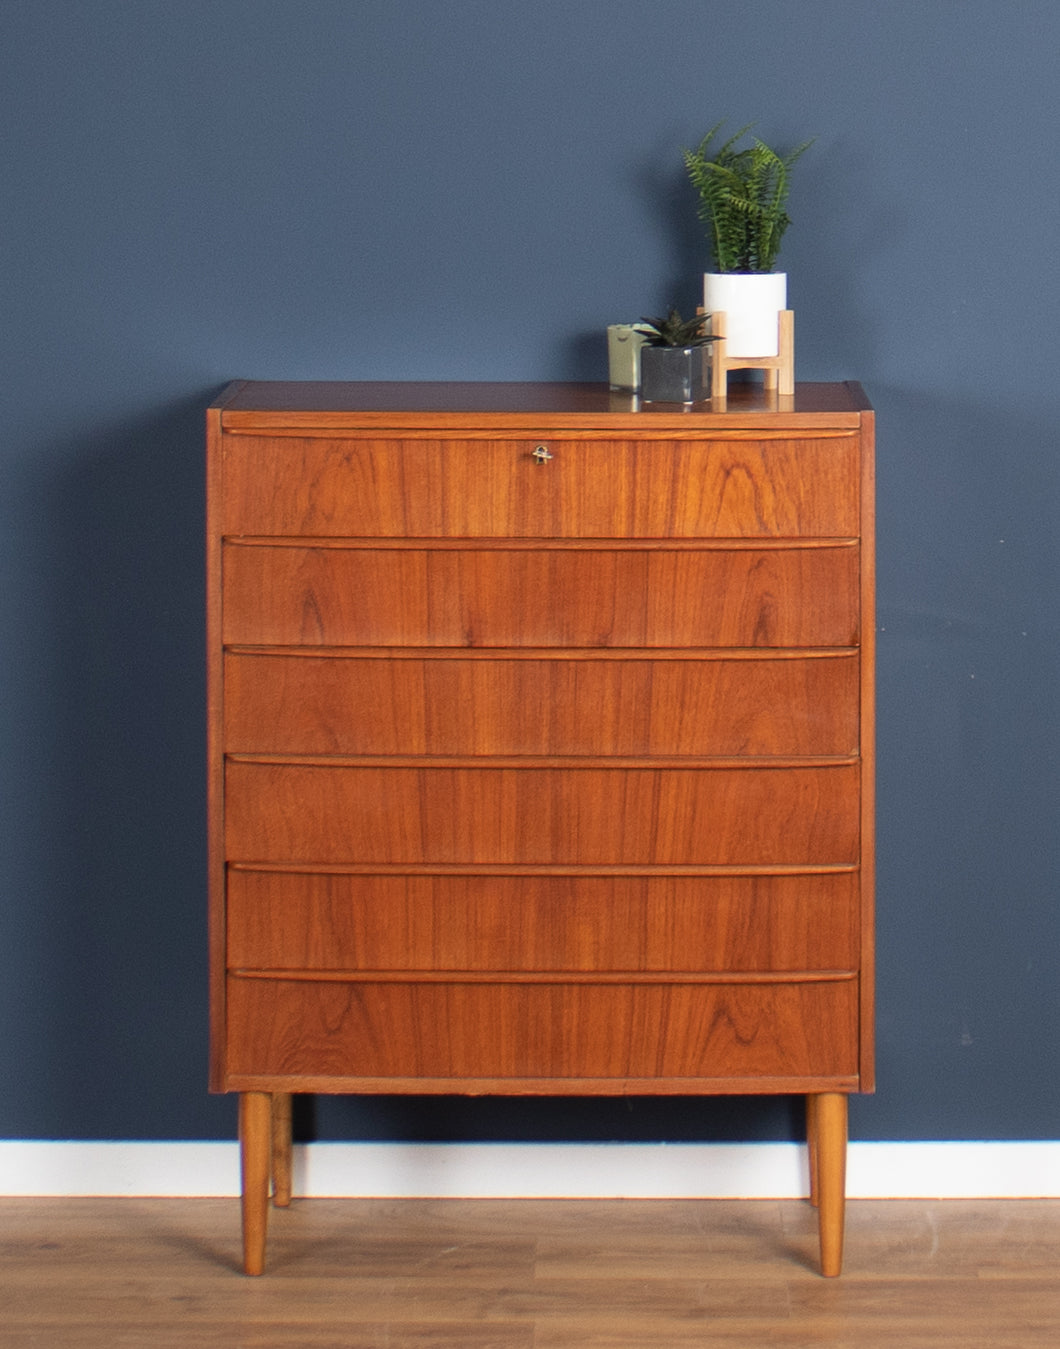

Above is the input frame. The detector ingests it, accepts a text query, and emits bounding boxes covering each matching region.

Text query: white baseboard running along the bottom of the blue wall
[0,1141,1060,1199]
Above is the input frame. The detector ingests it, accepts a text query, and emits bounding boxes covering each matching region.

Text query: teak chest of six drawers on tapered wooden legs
[208,383,874,1273]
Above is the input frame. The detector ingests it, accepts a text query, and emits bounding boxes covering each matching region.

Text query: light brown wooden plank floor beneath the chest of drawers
[0,1199,1060,1349]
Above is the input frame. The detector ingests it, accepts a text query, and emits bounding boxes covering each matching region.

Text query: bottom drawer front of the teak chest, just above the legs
[228,977,858,1081]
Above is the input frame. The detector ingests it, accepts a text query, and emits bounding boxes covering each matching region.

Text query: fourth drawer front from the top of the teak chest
[225,759,859,866]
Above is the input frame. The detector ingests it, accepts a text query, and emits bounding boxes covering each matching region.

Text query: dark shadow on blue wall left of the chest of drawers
[15,397,233,1139]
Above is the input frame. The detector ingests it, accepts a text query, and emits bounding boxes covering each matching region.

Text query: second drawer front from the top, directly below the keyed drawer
[223,544,858,648]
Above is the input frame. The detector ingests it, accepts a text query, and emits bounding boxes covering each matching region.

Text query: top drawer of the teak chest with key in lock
[221,432,859,538]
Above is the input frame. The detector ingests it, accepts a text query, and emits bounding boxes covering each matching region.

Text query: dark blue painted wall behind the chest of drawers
[0,0,1060,1139]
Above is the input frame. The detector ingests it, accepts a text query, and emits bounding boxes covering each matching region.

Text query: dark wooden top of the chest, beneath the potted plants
[214,380,870,430]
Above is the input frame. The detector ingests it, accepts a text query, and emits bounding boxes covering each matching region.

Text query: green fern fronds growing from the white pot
[684,121,813,271]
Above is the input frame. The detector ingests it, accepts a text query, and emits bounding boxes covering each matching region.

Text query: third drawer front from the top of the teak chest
[225,653,858,757]
